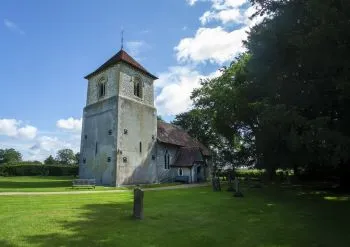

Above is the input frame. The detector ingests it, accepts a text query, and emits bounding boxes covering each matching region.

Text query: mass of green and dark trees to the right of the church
[173,0,350,189]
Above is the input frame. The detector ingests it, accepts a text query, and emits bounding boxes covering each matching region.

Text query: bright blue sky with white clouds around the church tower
[0,0,255,160]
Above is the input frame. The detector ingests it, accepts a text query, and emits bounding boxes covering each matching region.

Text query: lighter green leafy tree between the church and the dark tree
[190,54,256,171]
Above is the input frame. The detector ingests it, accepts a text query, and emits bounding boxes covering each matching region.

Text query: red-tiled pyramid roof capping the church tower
[84,50,158,79]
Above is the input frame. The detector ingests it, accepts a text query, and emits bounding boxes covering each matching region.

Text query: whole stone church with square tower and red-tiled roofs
[79,49,211,186]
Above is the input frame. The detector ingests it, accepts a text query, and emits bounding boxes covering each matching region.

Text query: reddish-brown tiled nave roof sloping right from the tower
[157,120,210,156]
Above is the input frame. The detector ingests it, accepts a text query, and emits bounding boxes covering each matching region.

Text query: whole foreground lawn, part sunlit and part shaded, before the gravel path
[0,186,350,247]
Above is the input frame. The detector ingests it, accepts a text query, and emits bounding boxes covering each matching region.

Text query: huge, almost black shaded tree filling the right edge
[246,0,350,181]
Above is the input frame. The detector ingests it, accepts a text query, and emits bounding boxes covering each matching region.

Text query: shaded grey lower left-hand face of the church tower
[79,97,117,186]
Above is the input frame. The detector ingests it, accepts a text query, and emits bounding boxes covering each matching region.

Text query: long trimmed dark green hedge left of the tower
[0,163,79,176]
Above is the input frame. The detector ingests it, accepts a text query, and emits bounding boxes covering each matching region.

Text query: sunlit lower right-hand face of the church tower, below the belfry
[117,96,157,184]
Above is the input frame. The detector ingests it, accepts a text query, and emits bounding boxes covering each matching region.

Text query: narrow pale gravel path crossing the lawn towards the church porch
[0,184,208,196]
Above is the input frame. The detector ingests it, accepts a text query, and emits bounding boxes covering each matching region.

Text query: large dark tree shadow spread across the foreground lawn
[21,187,350,247]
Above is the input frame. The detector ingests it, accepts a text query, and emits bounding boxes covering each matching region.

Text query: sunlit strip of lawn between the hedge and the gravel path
[0,176,178,193]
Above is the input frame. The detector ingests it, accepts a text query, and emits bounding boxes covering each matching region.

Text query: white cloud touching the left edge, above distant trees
[0,118,38,139]
